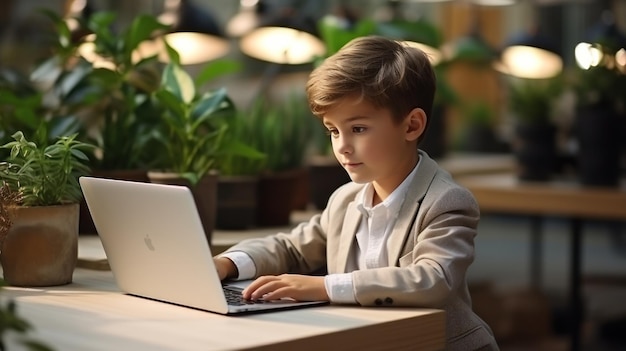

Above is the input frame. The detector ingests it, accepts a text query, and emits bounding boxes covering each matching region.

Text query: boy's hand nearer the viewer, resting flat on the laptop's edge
[243,274,329,301]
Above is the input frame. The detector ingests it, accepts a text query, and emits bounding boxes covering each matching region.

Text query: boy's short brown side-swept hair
[306,36,436,136]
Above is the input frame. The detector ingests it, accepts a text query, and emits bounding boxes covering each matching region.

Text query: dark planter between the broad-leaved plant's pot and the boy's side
[215,175,259,230]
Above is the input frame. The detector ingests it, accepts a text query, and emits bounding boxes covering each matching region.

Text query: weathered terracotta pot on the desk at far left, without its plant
[0,204,79,286]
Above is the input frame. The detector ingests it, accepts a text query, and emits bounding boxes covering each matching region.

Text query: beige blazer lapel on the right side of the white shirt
[387,150,439,267]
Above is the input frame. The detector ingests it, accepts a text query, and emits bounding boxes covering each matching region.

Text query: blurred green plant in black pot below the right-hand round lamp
[509,77,563,181]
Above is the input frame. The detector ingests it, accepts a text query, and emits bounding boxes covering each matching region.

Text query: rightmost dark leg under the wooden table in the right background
[570,218,584,351]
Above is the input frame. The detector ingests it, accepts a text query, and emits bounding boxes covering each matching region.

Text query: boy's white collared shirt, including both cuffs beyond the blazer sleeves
[222,161,420,304]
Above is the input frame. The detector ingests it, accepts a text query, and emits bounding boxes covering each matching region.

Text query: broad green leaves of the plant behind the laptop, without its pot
[152,48,261,184]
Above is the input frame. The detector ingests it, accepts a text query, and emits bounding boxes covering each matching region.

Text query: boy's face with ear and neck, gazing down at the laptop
[322,98,423,192]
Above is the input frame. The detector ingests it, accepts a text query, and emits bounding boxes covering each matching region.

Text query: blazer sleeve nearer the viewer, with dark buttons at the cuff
[353,177,480,308]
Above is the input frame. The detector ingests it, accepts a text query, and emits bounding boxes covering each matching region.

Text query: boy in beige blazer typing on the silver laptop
[215,36,498,350]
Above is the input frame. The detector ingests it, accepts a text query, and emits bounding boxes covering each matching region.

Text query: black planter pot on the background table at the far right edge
[576,105,625,187]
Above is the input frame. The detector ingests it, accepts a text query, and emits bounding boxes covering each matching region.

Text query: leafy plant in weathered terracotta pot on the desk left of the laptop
[0,132,93,286]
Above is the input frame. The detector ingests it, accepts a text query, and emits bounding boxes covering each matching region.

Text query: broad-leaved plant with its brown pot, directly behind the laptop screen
[148,48,256,242]
